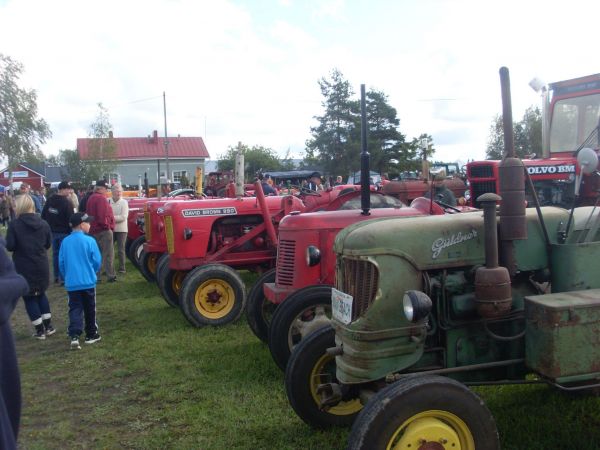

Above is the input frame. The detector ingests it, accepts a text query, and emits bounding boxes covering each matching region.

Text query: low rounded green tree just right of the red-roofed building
[218,144,289,182]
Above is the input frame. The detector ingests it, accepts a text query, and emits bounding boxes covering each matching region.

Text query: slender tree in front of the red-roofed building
[87,103,118,179]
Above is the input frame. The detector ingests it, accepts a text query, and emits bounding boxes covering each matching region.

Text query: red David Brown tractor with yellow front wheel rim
[156,182,390,326]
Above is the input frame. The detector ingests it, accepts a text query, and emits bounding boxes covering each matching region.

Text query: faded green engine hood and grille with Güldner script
[332,207,569,384]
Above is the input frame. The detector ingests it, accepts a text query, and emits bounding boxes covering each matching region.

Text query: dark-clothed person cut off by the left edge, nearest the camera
[0,237,29,450]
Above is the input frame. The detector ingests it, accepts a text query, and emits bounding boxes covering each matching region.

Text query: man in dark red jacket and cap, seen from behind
[85,180,117,282]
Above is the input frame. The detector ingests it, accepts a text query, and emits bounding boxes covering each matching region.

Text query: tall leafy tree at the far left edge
[0,53,52,182]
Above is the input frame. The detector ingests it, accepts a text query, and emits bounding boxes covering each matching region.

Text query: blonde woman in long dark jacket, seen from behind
[6,195,56,339]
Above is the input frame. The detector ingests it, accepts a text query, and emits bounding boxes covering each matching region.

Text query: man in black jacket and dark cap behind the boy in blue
[42,181,73,283]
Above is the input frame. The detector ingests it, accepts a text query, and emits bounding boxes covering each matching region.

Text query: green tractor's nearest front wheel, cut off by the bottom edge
[347,374,500,450]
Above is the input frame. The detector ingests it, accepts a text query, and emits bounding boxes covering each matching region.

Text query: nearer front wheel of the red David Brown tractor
[179,264,246,327]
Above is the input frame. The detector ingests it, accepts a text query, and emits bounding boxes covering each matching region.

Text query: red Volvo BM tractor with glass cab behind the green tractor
[467,74,600,208]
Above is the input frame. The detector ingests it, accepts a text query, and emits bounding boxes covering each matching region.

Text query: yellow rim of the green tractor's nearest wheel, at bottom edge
[386,409,475,450]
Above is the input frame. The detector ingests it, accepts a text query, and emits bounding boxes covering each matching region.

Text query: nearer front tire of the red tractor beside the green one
[269,285,331,370]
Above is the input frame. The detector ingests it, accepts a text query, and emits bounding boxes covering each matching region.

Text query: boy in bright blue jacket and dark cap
[58,213,102,350]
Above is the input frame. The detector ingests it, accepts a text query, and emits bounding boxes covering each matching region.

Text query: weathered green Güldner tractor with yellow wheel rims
[285,68,600,450]
